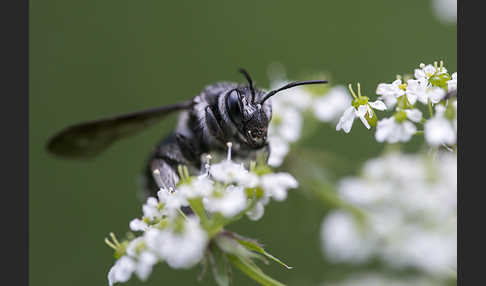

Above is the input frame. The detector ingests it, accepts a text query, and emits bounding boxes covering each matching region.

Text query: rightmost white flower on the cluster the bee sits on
[260,173,299,201]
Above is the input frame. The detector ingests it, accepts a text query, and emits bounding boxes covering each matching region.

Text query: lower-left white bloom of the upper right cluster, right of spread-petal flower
[375,117,417,143]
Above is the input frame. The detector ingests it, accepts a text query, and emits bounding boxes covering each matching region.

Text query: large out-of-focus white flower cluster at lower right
[321,152,457,277]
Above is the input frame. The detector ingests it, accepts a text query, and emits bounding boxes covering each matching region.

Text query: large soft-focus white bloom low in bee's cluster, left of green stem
[145,217,208,268]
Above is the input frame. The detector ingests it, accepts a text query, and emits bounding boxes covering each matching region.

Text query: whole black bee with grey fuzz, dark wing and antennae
[47,69,327,196]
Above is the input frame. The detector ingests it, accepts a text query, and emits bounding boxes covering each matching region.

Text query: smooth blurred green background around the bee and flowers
[29,0,457,286]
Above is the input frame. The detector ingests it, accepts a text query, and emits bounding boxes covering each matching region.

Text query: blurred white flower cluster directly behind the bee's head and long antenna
[268,75,351,167]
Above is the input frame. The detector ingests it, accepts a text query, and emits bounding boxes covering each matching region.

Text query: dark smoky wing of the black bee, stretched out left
[47,100,194,158]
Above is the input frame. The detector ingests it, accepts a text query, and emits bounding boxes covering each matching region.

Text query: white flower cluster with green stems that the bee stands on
[106,143,298,285]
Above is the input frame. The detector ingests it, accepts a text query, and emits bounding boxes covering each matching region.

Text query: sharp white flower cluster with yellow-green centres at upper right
[336,61,457,146]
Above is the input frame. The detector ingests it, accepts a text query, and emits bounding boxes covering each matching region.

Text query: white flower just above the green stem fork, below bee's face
[203,186,246,217]
